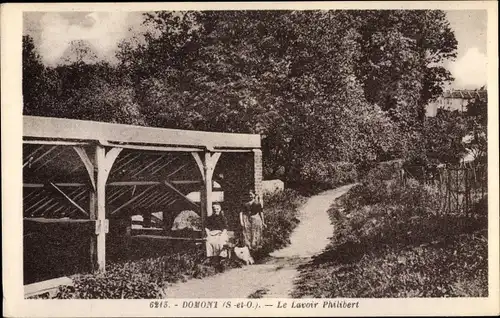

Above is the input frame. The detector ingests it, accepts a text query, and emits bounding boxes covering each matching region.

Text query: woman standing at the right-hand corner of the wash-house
[240,191,266,251]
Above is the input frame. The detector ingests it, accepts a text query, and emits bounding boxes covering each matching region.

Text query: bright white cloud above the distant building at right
[450,47,488,89]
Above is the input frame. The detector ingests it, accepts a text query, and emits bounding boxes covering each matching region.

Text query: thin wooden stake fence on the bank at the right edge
[400,164,488,214]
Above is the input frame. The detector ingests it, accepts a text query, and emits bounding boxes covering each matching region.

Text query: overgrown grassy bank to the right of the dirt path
[294,171,488,298]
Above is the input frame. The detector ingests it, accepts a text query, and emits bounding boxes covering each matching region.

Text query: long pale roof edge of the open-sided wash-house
[23,116,261,150]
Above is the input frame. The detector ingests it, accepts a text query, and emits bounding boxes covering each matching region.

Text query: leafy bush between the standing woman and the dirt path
[258,189,306,255]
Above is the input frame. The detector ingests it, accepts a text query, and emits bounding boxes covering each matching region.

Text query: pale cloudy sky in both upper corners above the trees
[23,10,487,89]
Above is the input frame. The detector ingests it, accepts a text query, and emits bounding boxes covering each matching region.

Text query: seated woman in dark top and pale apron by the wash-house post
[205,203,229,257]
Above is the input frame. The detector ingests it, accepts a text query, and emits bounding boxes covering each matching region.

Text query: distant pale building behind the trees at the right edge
[426,88,487,117]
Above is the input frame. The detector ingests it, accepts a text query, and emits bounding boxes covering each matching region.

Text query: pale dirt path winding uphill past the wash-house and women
[166,185,353,298]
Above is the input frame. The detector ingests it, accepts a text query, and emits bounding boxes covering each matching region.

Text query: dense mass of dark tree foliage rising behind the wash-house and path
[23,10,456,183]
